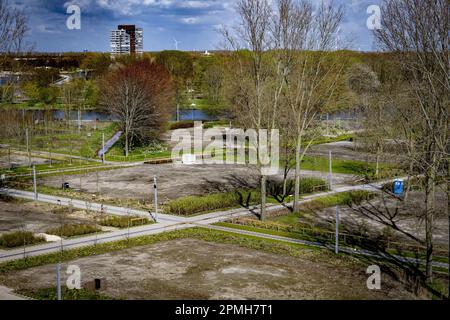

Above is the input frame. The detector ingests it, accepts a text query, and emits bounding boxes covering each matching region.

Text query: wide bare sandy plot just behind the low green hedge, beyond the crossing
[40,164,354,203]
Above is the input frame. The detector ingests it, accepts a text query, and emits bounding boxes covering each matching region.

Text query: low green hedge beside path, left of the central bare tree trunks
[165,191,261,216]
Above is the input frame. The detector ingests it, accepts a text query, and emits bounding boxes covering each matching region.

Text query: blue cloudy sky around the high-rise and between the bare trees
[9,0,381,52]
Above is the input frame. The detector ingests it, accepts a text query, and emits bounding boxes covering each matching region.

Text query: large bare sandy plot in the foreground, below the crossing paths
[0,239,414,300]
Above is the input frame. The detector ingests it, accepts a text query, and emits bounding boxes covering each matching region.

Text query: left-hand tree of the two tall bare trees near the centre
[222,0,274,220]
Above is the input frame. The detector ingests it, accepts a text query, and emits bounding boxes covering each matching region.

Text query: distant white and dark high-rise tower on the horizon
[110,25,144,55]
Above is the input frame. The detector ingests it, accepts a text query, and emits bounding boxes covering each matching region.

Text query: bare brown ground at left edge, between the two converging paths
[0,200,95,234]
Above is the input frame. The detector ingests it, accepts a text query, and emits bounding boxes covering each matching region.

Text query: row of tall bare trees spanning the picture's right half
[223,0,450,290]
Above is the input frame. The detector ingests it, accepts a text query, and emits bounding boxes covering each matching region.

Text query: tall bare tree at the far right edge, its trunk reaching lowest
[375,0,450,279]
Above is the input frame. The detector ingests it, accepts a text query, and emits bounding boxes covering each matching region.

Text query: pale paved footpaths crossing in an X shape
[0,181,448,268]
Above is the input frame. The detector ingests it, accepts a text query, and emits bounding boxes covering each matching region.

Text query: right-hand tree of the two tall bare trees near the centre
[272,0,344,215]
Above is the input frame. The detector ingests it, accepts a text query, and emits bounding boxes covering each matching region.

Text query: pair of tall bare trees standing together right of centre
[223,0,346,219]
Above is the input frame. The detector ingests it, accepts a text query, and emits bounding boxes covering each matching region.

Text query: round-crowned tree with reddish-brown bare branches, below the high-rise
[101,60,173,157]
